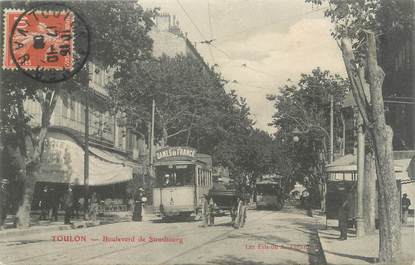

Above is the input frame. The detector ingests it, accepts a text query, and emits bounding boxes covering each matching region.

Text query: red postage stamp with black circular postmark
[3,9,74,71]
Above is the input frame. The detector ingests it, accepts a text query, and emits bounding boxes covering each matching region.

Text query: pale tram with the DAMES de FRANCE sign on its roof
[153,146,213,219]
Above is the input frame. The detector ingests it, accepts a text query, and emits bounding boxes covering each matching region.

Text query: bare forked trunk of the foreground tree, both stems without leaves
[340,32,401,263]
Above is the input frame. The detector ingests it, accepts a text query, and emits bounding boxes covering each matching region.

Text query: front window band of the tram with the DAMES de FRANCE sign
[156,165,195,187]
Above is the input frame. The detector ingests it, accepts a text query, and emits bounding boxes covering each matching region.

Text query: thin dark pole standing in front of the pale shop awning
[84,88,89,220]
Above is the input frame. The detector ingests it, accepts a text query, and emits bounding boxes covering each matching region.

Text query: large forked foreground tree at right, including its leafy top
[306,0,412,263]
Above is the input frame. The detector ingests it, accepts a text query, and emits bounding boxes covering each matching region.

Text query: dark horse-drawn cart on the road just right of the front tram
[208,182,247,228]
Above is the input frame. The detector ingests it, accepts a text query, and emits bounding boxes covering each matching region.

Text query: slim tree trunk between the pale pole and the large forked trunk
[363,148,377,235]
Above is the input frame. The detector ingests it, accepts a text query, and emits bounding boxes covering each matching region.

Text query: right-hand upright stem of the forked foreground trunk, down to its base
[367,33,401,262]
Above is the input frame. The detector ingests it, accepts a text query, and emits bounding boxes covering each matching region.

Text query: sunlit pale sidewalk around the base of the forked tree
[318,218,415,265]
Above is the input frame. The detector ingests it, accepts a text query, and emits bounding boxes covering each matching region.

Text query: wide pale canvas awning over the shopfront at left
[37,132,133,186]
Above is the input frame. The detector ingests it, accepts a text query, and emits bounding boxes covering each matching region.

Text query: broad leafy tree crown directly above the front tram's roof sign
[107,55,252,157]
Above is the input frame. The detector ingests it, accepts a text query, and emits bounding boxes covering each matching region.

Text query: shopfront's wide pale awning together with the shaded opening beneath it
[33,132,139,208]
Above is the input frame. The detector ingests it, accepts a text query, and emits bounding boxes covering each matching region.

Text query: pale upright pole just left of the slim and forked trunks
[356,112,365,237]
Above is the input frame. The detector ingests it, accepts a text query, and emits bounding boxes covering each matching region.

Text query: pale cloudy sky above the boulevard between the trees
[139,0,345,133]
